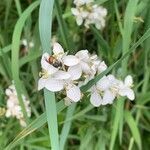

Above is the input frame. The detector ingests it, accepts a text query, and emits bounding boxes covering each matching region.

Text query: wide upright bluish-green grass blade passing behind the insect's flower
[39,0,59,150]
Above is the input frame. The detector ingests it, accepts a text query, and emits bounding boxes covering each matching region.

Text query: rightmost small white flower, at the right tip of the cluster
[119,75,135,100]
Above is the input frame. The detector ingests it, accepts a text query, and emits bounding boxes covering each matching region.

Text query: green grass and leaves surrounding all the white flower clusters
[0,0,150,150]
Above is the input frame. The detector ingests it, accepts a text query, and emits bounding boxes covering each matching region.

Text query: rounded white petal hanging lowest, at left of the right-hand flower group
[90,91,102,107]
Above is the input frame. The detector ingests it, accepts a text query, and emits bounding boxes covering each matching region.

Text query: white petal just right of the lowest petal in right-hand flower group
[102,90,115,105]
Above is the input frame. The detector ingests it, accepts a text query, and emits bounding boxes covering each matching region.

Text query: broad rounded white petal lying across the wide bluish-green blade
[45,78,64,92]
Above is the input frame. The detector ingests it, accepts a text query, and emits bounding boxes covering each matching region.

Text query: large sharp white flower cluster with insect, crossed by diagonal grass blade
[38,43,135,107]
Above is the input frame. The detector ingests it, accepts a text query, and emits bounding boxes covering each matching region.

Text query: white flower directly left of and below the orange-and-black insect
[38,53,70,92]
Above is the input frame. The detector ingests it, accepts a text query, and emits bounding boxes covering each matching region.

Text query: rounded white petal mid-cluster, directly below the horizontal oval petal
[68,64,82,80]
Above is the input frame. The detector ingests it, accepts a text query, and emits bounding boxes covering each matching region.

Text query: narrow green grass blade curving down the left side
[11,1,40,122]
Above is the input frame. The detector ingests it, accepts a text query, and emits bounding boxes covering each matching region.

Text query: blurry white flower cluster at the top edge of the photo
[71,0,107,30]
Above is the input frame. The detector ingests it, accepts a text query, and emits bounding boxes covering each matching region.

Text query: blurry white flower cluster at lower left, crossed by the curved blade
[5,84,31,127]
